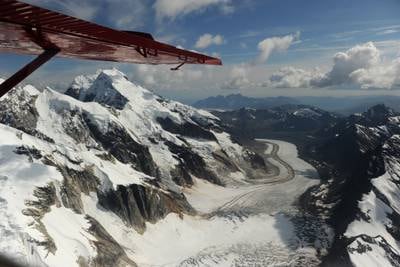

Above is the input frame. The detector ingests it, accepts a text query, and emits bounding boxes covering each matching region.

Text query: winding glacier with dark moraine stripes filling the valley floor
[115,140,332,266]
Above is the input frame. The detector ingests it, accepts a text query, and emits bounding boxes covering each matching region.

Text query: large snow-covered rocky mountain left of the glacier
[0,69,266,266]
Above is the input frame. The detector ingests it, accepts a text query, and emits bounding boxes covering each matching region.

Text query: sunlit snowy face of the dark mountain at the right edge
[345,130,400,266]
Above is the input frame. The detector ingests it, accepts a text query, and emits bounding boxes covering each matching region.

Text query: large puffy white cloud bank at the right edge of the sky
[265,42,400,89]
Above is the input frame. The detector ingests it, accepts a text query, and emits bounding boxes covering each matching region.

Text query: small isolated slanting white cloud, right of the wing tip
[256,32,300,63]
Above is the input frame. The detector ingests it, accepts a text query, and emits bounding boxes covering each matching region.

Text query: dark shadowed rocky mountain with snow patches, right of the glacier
[296,105,400,266]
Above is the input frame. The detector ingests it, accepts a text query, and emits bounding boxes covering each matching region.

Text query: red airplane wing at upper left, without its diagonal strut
[0,0,221,65]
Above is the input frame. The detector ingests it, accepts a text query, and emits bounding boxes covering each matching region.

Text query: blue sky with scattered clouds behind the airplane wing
[0,0,400,100]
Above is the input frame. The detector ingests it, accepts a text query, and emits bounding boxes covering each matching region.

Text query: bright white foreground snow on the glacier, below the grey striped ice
[81,196,296,266]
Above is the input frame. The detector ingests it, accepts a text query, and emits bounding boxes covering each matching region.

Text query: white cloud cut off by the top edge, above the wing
[153,0,233,20]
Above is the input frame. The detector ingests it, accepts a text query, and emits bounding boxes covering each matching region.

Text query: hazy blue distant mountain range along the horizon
[193,94,400,115]
